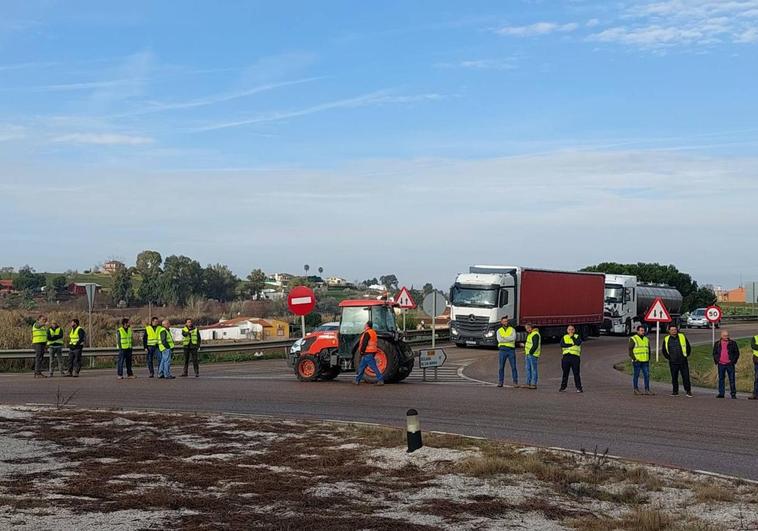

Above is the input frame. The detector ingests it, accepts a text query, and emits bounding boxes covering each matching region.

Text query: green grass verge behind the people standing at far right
[616,338,755,393]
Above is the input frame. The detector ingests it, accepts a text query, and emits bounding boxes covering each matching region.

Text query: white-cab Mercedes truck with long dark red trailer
[450,265,605,347]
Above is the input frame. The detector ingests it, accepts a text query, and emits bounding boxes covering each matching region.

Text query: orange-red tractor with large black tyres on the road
[290,299,414,382]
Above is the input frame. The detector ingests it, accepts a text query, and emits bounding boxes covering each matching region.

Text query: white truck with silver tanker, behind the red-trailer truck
[602,275,682,336]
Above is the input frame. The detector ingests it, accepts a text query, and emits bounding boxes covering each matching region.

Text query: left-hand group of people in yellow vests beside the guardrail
[32,315,201,380]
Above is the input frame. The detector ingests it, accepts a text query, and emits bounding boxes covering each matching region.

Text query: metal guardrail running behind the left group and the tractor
[0,328,450,360]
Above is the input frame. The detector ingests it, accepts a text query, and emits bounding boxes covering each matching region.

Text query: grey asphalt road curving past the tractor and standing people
[0,325,758,480]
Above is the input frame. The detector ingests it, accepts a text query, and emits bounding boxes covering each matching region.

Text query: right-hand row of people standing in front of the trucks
[497,317,758,400]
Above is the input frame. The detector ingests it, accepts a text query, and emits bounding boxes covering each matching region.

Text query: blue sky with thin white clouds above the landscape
[0,0,758,288]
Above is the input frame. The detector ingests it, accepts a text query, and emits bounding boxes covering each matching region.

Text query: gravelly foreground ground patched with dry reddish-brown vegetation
[0,406,758,531]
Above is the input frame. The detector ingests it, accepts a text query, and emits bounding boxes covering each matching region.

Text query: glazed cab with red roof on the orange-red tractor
[338,299,397,359]
